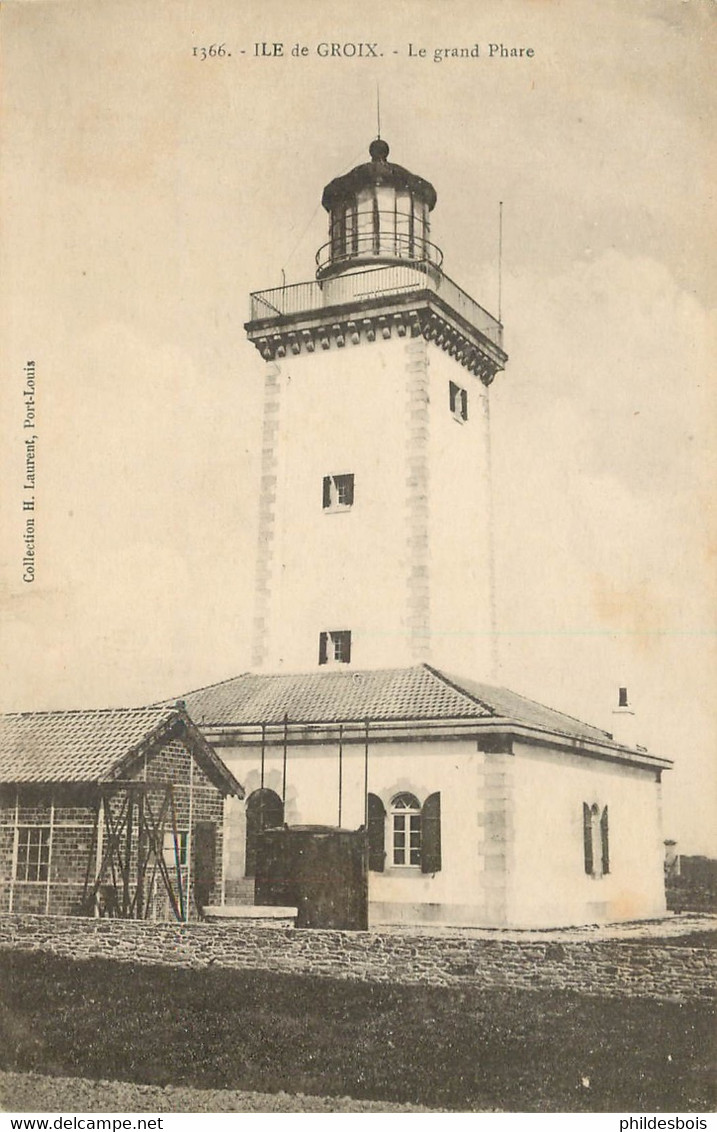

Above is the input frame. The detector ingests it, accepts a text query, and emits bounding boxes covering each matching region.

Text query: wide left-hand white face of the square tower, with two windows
[255,338,408,671]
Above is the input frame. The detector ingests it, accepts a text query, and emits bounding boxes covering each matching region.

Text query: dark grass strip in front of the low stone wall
[0,951,715,1112]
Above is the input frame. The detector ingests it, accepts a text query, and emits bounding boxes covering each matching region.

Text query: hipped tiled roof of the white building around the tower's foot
[166,664,609,741]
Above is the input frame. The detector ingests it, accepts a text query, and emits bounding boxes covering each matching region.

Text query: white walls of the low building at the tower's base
[217,738,665,927]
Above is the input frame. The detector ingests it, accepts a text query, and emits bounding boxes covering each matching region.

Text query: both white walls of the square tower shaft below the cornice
[250,335,492,672]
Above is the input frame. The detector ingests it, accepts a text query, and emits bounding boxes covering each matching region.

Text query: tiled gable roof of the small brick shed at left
[0,705,241,790]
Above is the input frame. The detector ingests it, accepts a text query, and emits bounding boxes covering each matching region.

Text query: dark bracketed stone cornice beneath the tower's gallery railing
[245,291,507,385]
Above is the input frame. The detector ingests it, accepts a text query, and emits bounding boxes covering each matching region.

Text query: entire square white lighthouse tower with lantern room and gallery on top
[246,139,506,677]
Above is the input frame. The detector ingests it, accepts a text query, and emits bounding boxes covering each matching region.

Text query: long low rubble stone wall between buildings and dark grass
[0,915,716,1002]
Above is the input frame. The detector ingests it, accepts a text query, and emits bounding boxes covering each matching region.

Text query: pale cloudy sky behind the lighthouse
[0,0,717,855]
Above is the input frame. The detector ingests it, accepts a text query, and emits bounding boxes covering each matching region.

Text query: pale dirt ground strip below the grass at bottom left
[0,1072,434,1115]
